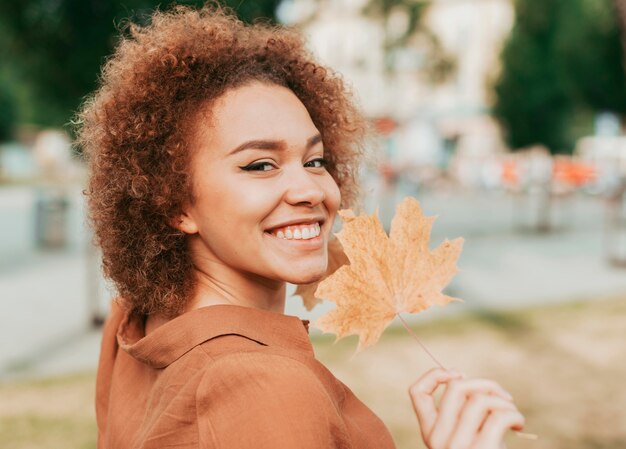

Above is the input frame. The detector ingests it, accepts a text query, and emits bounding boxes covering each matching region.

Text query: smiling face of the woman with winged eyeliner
[180,82,340,284]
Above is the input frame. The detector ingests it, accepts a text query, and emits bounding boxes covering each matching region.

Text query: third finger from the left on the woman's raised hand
[449,394,517,449]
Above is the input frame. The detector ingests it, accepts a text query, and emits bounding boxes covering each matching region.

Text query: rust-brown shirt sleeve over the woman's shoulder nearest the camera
[195,337,393,449]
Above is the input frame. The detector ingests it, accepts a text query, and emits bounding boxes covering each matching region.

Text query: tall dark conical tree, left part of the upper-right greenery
[494,0,578,152]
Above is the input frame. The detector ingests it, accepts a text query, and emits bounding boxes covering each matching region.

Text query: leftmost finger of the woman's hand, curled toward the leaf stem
[409,368,461,441]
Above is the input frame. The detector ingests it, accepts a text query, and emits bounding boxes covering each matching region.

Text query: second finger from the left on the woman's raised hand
[430,379,513,447]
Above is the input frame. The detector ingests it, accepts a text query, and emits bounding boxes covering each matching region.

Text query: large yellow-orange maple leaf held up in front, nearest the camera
[314,198,463,352]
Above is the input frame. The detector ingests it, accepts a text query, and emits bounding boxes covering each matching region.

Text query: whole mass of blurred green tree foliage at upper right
[494,0,626,153]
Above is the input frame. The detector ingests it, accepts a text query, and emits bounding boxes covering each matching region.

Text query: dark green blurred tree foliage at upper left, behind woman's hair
[0,0,280,130]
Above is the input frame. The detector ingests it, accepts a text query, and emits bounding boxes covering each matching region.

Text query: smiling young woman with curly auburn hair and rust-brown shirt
[79,7,523,449]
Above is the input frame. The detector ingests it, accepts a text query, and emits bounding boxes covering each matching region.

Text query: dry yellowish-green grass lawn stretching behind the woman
[0,298,626,449]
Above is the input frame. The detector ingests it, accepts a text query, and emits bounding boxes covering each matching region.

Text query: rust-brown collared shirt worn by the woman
[96,303,394,449]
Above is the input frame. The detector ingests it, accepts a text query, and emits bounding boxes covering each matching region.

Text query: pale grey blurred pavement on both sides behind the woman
[0,184,626,380]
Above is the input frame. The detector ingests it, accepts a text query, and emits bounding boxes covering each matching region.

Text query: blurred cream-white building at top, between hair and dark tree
[279,0,514,191]
